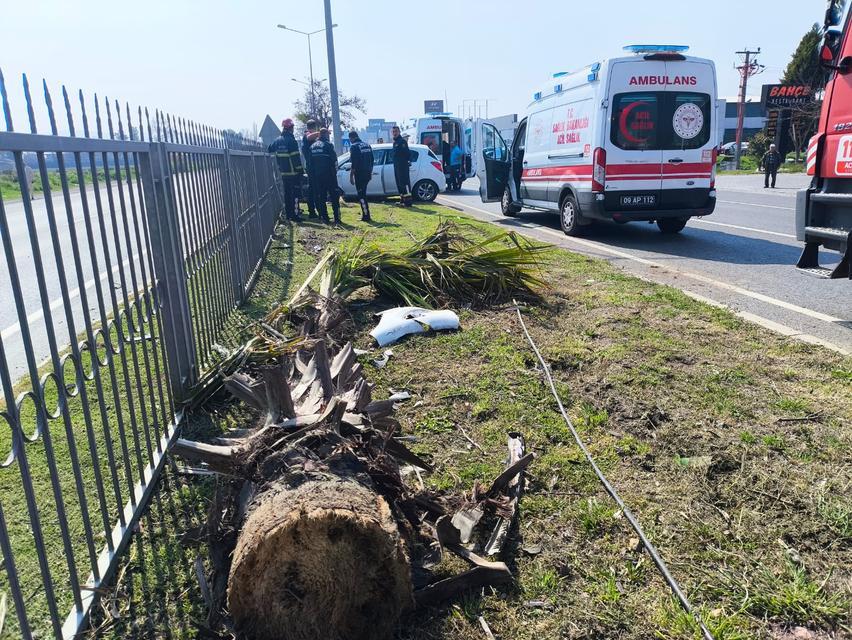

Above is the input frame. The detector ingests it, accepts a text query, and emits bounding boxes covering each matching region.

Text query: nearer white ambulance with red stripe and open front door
[470,45,724,235]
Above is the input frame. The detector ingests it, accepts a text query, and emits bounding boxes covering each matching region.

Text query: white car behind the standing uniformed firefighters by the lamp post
[337,143,447,202]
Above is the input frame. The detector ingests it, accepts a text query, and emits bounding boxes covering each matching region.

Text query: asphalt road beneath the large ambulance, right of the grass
[438,175,852,353]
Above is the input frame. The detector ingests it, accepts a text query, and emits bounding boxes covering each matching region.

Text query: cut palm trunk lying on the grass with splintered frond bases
[173,341,422,640]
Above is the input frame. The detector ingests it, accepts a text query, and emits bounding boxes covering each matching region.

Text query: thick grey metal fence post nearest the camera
[140,142,198,400]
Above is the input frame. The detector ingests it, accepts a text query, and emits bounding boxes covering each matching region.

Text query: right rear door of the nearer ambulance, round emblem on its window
[659,59,717,209]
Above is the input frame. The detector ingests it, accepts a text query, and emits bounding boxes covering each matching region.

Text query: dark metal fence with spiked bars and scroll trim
[0,67,281,638]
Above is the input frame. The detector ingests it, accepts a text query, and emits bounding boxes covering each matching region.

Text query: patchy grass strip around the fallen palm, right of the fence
[88,204,852,640]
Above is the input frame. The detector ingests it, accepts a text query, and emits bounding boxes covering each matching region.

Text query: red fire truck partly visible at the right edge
[796,0,852,279]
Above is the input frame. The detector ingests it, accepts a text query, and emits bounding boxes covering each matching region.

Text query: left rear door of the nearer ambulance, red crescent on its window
[604,58,666,212]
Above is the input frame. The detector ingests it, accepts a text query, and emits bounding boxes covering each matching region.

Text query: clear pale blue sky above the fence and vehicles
[0,0,826,135]
